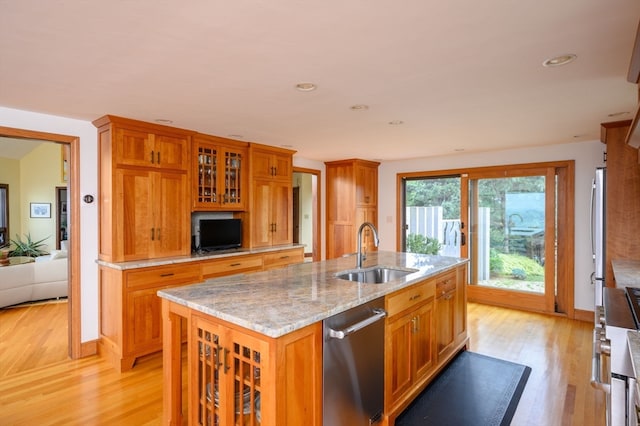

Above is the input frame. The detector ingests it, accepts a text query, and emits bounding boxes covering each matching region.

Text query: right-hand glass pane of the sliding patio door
[469,175,546,294]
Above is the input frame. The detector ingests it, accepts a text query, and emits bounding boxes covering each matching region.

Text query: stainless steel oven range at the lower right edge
[591,288,640,426]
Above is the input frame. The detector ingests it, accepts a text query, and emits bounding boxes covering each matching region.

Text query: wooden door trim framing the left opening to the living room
[0,126,82,359]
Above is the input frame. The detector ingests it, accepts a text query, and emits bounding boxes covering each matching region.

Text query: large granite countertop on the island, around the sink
[158,252,467,337]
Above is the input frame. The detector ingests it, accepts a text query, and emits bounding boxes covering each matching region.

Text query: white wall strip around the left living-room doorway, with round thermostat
[0,107,98,342]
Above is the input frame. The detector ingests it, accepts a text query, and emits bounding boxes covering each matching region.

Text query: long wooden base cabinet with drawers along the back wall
[99,247,304,372]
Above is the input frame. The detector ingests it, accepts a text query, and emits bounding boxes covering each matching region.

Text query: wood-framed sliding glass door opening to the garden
[398,161,574,318]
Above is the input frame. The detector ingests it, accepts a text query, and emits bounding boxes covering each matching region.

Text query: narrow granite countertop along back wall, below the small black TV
[96,244,304,271]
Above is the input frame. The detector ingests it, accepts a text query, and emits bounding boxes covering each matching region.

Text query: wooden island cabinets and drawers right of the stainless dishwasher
[385,265,468,424]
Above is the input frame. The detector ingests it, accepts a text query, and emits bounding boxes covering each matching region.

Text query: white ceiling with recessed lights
[0,0,640,161]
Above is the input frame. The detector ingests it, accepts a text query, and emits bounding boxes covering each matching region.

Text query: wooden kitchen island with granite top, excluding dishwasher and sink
[158,252,468,426]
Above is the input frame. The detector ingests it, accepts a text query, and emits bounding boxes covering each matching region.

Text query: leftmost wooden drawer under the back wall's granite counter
[125,262,200,288]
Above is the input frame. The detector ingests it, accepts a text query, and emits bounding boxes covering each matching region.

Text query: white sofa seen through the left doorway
[0,250,69,308]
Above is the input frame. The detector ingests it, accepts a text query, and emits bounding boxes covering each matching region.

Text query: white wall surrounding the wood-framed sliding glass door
[378,141,605,310]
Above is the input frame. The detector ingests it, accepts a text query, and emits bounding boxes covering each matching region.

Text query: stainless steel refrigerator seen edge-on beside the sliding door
[591,167,607,306]
